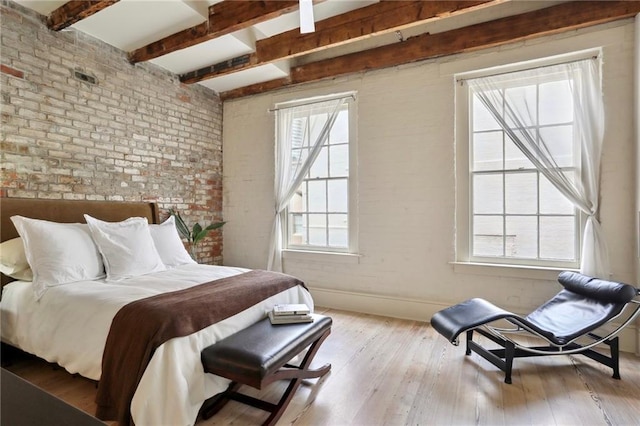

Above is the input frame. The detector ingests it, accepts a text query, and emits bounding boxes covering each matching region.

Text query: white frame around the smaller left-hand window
[278,94,358,253]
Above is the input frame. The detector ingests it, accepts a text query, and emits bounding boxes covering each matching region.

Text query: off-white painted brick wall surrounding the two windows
[223,20,635,346]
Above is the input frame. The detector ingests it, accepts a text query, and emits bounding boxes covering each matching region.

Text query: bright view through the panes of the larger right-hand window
[469,68,581,264]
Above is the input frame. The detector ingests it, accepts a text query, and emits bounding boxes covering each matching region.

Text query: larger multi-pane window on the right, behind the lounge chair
[457,57,596,268]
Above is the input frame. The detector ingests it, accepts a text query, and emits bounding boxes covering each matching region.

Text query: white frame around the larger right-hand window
[455,51,593,270]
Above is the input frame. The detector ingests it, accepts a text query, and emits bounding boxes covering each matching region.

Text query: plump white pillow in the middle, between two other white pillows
[84,214,167,281]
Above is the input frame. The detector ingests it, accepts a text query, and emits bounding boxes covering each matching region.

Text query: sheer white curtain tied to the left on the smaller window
[267,95,351,271]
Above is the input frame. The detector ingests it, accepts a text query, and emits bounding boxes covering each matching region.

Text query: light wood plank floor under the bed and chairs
[1,309,640,426]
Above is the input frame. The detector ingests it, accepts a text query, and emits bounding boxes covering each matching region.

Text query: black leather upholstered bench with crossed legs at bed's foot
[200,314,332,425]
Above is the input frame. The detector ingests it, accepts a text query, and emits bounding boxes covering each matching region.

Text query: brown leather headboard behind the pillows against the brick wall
[0,198,159,284]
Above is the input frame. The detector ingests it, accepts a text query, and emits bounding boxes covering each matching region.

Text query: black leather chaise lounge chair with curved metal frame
[431,271,640,383]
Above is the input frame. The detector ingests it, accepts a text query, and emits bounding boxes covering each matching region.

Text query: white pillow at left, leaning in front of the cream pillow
[11,216,104,299]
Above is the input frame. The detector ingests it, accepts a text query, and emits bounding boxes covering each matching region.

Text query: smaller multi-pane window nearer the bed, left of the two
[274,96,356,253]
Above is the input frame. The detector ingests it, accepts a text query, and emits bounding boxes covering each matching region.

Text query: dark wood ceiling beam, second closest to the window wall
[180,0,504,84]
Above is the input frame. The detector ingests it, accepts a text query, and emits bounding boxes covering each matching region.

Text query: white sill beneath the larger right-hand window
[450,262,578,281]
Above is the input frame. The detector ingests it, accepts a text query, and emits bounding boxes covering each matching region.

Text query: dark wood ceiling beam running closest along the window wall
[221,1,640,100]
